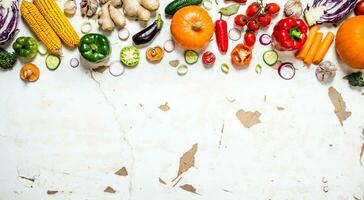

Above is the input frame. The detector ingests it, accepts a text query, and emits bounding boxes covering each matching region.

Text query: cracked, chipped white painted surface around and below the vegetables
[0,0,364,200]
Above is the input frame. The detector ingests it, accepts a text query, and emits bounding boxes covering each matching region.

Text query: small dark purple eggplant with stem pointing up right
[133,14,163,45]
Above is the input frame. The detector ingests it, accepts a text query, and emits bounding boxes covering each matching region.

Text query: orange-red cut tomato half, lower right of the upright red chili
[230,44,253,69]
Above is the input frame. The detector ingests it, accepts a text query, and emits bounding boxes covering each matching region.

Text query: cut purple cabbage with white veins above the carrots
[304,0,358,26]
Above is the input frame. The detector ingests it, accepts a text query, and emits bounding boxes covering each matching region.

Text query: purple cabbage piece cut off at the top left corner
[0,0,19,45]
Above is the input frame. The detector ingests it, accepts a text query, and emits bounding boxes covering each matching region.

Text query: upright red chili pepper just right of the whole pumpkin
[215,19,229,53]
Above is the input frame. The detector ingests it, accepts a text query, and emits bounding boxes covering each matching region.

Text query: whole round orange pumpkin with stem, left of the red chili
[171,6,214,50]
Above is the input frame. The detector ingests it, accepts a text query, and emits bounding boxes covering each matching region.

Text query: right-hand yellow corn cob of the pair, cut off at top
[34,0,80,48]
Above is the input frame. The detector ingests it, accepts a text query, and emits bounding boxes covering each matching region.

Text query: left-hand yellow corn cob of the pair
[20,1,62,55]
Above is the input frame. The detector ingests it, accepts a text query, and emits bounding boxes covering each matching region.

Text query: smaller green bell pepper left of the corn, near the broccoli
[13,37,38,59]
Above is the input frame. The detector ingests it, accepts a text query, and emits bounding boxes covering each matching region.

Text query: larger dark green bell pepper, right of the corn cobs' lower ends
[78,33,111,63]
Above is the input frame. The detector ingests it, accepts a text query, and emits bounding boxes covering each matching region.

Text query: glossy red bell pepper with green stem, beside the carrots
[272,17,308,51]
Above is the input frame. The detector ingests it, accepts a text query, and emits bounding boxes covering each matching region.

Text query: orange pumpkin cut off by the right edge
[335,16,364,69]
